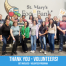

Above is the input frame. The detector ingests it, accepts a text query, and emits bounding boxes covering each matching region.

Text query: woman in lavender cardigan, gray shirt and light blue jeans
[30,20,38,53]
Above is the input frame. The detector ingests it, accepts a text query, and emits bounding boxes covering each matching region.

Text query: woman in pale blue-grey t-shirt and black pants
[10,21,20,55]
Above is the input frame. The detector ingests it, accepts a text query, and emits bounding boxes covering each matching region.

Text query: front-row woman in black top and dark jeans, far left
[0,19,10,55]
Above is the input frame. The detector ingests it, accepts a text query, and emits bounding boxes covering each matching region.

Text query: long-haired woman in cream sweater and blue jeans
[48,19,56,53]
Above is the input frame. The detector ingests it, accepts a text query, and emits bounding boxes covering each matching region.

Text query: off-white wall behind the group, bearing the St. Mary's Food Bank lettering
[0,0,64,20]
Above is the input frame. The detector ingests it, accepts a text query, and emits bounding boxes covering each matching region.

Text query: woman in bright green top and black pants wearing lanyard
[21,21,30,53]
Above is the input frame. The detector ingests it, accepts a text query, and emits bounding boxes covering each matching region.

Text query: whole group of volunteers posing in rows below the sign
[0,14,66,55]
